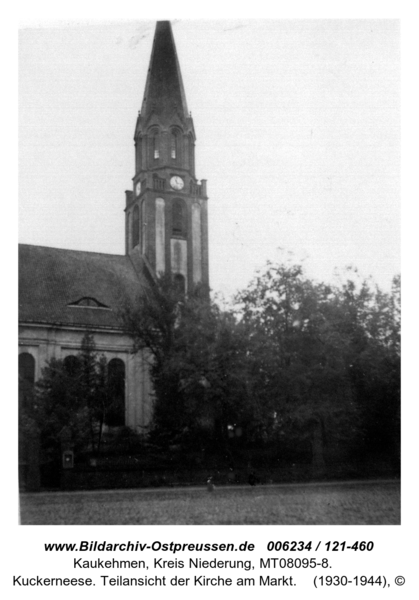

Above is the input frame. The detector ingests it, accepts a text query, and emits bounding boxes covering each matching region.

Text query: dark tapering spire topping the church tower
[141,21,189,123]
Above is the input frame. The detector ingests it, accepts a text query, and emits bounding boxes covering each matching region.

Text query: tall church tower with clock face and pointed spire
[125,21,209,292]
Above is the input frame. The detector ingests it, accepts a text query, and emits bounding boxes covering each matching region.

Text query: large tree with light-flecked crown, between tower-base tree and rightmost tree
[236,262,398,472]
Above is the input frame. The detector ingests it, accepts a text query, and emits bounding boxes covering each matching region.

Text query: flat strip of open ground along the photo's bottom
[20,482,400,525]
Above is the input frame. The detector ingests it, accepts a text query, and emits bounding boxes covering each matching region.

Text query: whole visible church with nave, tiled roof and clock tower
[19,21,209,431]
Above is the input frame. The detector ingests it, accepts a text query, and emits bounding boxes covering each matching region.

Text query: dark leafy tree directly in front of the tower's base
[123,276,247,451]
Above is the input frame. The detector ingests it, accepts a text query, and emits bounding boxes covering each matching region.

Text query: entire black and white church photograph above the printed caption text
[16,11,401,528]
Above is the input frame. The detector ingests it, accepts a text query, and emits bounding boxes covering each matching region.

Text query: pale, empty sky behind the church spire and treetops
[19,19,400,297]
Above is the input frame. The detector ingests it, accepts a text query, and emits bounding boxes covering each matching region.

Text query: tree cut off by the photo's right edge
[334,270,400,463]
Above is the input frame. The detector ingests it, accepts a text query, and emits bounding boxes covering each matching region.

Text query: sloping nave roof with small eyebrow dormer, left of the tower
[19,244,147,329]
